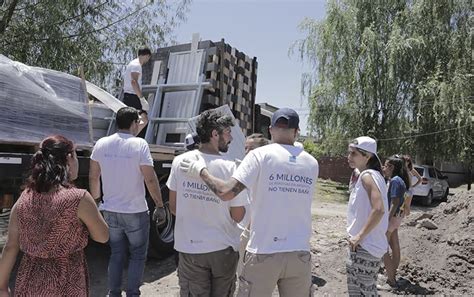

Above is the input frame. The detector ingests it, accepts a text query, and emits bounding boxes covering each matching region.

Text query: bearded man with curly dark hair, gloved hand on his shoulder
[166,110,248,297]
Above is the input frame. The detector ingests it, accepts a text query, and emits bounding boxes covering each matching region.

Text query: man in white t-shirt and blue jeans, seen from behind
[89,107,166,297]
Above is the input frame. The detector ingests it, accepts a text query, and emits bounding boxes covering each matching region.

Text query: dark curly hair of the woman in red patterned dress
[25,135,75,193]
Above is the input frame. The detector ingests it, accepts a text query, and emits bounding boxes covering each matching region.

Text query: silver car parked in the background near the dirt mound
[413,165,449,206]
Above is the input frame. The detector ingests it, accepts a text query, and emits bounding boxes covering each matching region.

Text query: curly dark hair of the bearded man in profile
[196,109,234,143]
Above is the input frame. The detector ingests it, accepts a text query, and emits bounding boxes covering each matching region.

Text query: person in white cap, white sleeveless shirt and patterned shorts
[346,136,388,296]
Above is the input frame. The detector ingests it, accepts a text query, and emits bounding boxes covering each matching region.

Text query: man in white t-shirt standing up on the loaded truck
[123,48,151,133]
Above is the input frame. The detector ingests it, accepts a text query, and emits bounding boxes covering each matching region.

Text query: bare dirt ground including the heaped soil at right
[0,185,474,296]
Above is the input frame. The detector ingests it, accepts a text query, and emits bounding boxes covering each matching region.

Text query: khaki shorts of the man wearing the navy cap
[237,251,313,297]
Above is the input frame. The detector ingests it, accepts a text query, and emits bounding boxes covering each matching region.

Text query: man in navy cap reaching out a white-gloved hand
[180,108,319,296]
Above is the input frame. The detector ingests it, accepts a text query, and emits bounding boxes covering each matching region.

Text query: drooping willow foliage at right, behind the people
[294,0,474,162]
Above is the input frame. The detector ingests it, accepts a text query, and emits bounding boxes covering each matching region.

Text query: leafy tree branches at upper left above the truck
[0,0,190,88]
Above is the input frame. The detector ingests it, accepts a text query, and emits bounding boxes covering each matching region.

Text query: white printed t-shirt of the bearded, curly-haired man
[166,150,249,254]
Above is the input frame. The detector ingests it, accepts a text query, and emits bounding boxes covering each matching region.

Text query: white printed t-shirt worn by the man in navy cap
[232,143,319,254]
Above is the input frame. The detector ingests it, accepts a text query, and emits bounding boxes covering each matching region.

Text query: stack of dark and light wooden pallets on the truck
[143,39,258,135]
